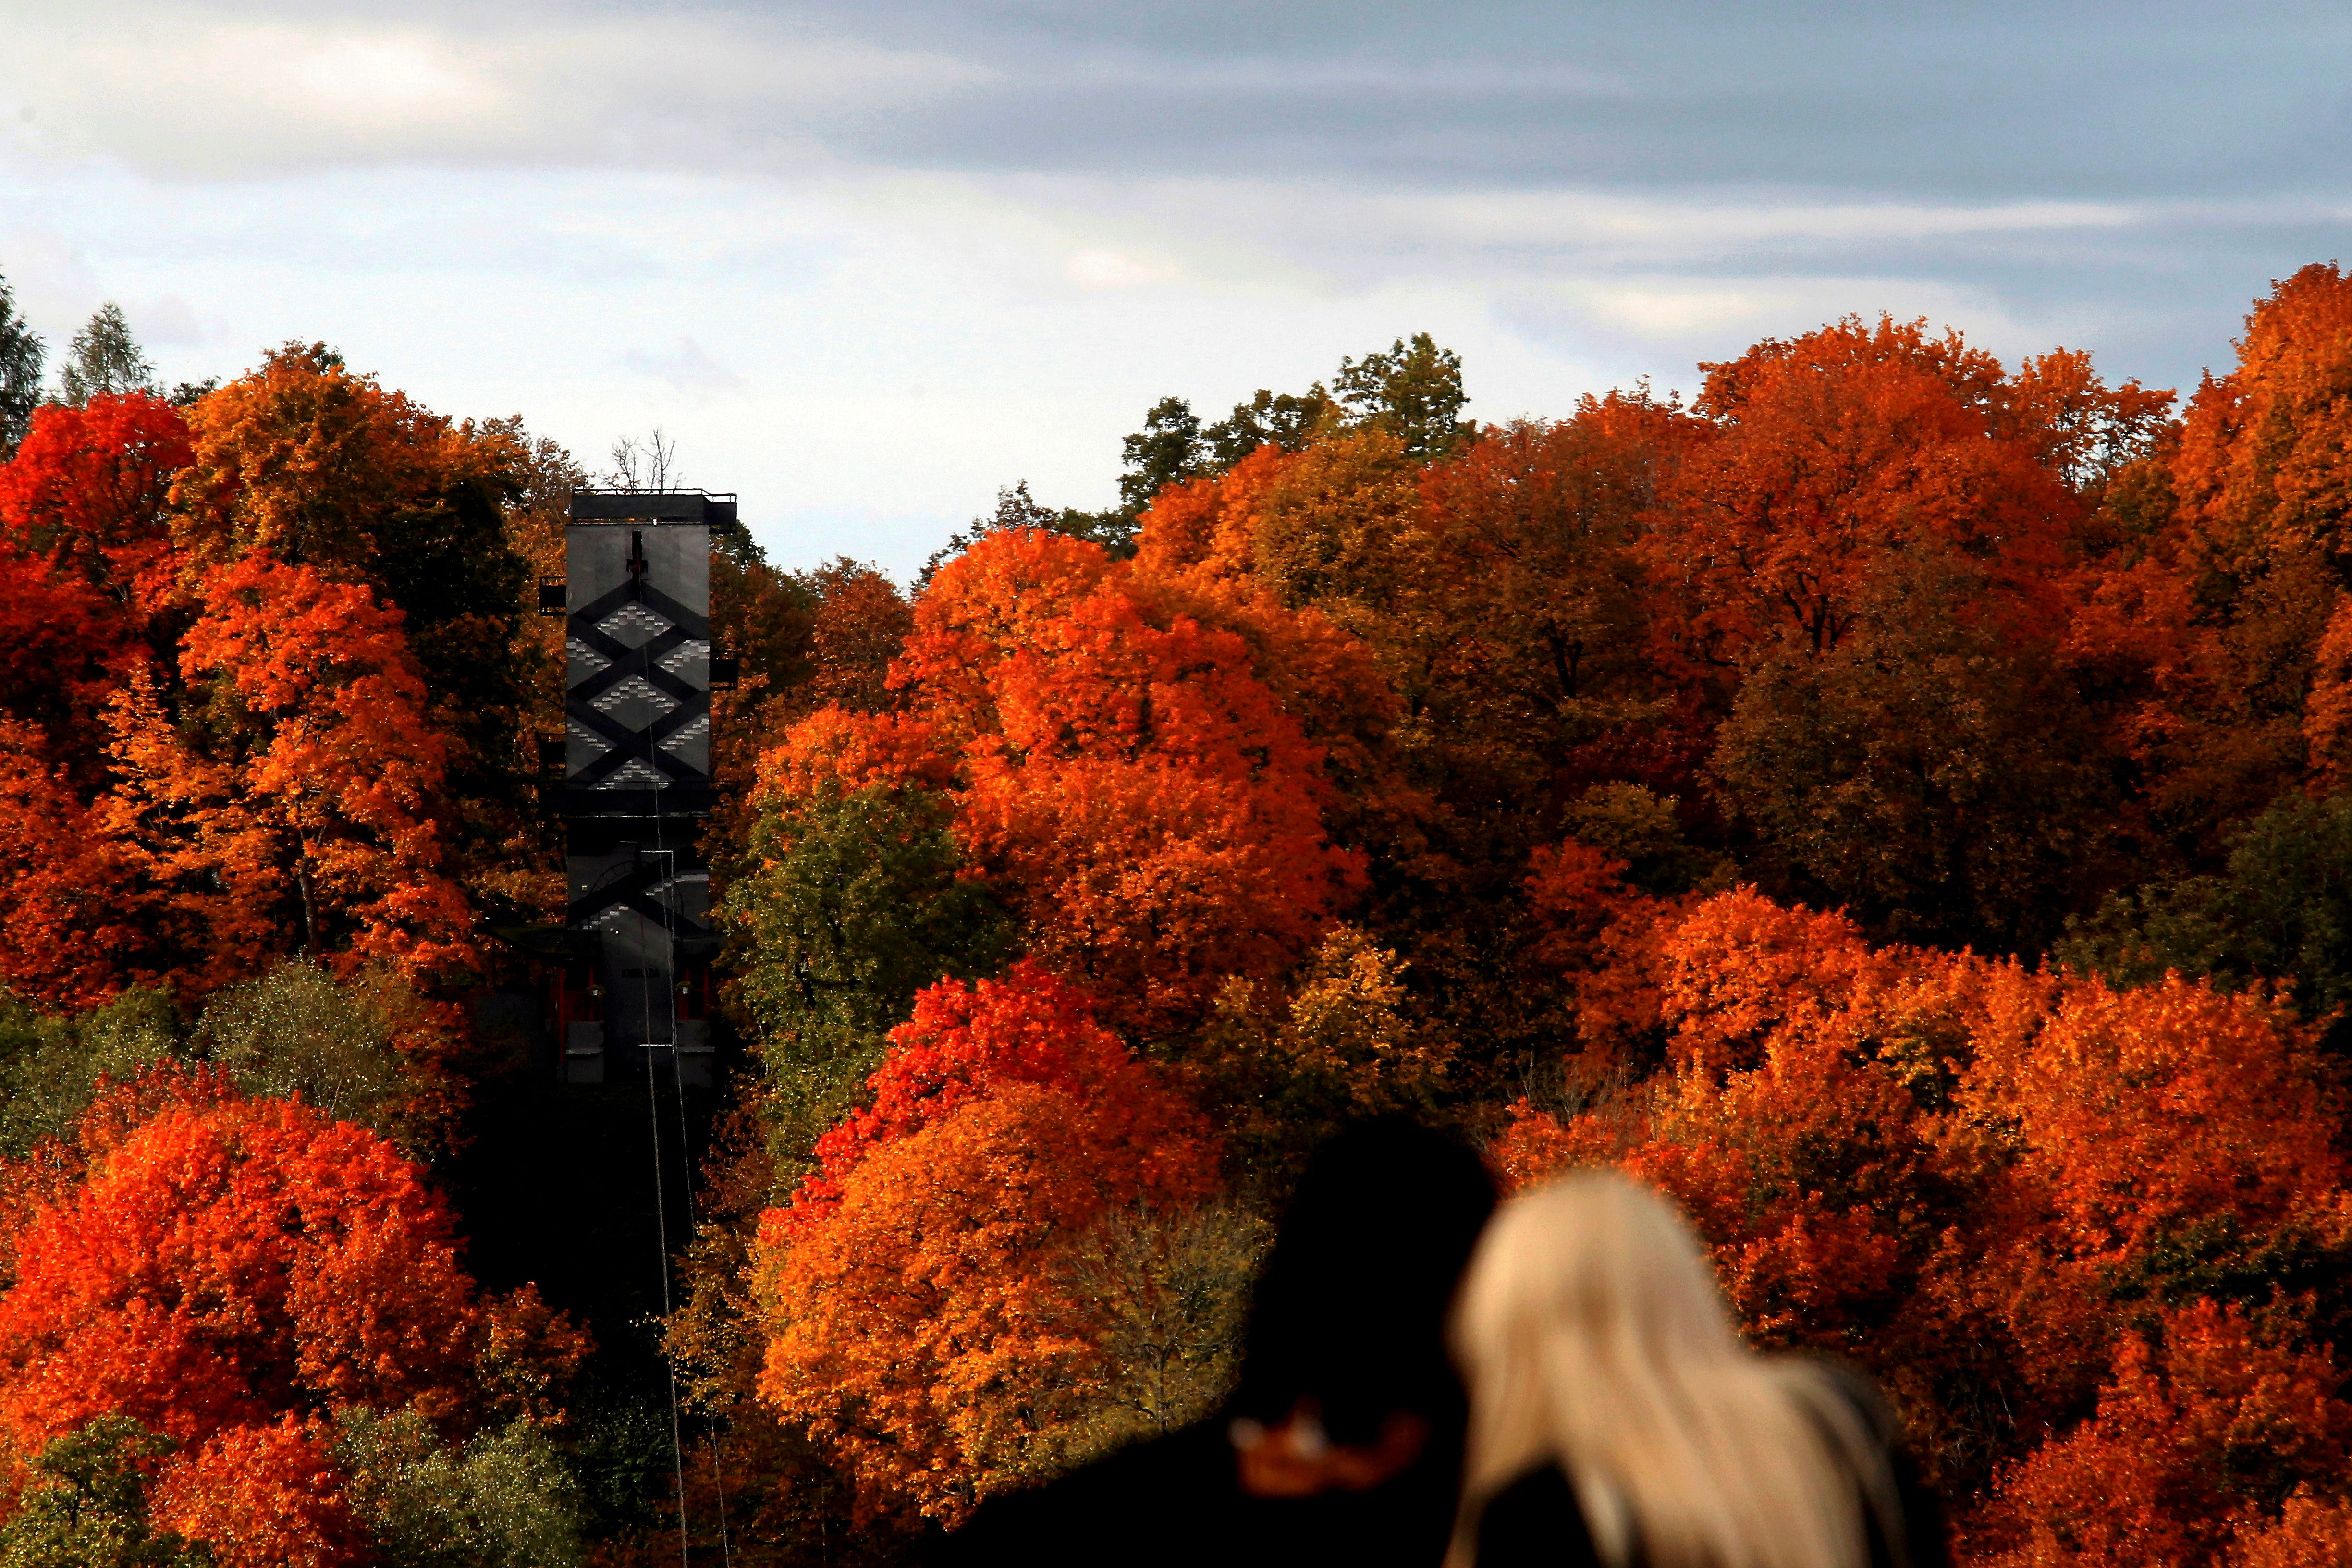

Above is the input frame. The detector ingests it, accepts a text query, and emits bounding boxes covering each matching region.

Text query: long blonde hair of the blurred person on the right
[1449,1173,1900,1568]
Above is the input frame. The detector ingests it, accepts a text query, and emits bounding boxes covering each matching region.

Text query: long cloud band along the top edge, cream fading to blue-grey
[0,0,2352,205]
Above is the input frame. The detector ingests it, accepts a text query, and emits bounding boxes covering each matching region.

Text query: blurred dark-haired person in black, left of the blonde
[941,1116,1496,1568]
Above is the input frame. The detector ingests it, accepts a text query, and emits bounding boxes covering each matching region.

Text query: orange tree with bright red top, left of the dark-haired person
[753,966,1216,1523]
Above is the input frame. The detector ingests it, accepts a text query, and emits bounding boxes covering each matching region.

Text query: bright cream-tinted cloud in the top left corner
[0,2,988,179]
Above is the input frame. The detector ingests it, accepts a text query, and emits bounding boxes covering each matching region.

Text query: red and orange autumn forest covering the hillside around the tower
[0,266,2352,1568]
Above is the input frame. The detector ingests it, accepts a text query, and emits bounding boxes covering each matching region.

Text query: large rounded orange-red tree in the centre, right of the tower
[764,529,1362,1032]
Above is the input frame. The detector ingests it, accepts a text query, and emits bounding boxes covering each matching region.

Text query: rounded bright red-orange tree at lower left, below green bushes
[0,1079,478,1450]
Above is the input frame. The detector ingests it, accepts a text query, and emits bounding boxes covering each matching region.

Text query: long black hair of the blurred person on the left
[1230,1116,1494,1444]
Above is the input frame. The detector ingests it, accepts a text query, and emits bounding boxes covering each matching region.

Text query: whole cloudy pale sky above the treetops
[0,0,2352,576]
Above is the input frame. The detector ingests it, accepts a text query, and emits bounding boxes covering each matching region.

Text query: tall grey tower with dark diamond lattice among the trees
[557,491,736,1084]
